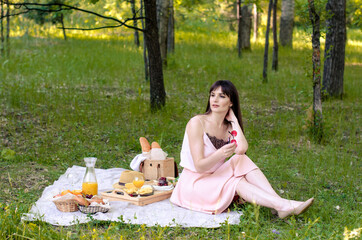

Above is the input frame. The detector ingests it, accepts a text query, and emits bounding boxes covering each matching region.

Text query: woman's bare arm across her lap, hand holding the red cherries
[186,116,236,172]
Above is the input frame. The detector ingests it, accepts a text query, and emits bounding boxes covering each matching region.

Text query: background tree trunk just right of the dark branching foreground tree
[159,0,170,66]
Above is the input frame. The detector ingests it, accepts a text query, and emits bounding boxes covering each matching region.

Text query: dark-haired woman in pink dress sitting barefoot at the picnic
[170,80,314,218]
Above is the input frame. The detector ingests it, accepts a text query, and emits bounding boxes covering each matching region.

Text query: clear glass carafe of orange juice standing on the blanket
[82,157,98,196]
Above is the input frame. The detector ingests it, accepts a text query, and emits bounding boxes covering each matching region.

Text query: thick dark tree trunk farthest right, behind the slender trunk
[322,0,346,98]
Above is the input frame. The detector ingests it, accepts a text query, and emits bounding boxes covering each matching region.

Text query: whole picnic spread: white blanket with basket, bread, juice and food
[22,138,242,228]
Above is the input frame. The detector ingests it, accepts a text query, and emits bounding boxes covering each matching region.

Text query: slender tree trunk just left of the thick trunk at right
[308,0,323,142]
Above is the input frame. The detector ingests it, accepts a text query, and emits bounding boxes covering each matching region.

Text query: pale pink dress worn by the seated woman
[170,132,258,214]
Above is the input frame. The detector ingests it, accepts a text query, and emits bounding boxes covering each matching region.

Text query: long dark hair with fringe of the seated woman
[205,80,244,132]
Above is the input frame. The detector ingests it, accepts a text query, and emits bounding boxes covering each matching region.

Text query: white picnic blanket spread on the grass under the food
[22,166,242,228]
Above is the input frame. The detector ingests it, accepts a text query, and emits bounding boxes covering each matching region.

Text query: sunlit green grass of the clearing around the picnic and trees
[0,22,362,239]
